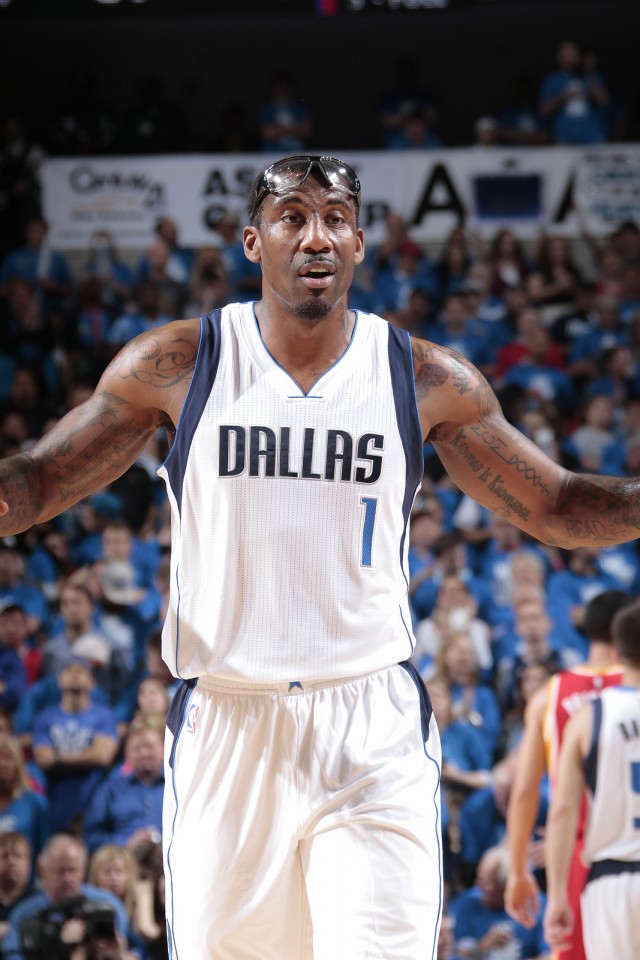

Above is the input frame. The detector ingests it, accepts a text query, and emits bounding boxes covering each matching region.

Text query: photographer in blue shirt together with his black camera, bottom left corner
[3,834,128,960]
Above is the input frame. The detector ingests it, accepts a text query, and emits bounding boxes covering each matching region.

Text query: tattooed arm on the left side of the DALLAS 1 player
[0,320,200,537]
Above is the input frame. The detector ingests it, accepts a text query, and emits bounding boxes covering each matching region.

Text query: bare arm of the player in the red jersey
[505,685,549,928]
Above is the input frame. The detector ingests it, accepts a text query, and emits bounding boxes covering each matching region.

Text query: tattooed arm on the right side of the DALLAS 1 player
[412,340,640,548]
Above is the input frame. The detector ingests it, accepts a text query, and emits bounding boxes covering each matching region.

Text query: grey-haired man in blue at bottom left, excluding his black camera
[3,834,129,960]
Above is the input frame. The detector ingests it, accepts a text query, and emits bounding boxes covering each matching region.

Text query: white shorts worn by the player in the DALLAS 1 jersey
[163,665,442,960]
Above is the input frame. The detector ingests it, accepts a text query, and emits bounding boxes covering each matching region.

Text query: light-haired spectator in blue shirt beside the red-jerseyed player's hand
[448,846,549,960]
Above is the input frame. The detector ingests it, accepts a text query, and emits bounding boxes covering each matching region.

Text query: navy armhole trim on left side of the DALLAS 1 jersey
[165,310,222,512]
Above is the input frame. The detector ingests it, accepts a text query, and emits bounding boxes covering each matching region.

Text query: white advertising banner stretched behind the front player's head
[42,145,640,250]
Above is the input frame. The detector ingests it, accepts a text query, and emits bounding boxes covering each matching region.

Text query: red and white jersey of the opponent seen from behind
[542,667,622,835]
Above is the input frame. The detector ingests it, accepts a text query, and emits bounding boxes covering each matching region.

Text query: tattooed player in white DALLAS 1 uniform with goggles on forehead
[0,156,640,960]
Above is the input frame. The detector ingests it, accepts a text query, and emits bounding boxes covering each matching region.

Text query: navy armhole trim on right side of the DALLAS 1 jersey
[389,324,424,576]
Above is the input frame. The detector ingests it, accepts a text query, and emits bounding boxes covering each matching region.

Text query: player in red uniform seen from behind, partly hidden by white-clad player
[505,590,633,960]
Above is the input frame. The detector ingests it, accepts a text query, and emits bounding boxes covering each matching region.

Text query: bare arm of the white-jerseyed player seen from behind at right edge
[544,704,593,950]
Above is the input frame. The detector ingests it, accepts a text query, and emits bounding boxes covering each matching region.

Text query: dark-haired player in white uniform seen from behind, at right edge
[544,603,640,960]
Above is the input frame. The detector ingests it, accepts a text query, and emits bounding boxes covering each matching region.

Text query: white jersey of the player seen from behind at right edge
[584,687,640,863]
